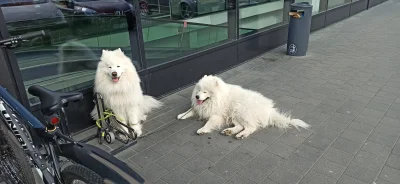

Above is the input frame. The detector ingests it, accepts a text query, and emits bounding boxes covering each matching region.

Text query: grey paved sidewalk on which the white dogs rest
[76,0,400,184]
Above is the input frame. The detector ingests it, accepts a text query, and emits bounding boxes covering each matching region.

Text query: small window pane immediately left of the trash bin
[239,0,286,36]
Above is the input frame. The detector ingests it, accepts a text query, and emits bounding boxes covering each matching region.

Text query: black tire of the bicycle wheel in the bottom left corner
[0,118,36,184]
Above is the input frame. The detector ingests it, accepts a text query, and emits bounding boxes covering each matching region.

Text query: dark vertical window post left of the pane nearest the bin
[226,0,239,40]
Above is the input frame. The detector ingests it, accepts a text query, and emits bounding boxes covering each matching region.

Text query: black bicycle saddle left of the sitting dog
[28,85,83,116]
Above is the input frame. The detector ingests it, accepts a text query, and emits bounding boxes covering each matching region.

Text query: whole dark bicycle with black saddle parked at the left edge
[0,31,145,184]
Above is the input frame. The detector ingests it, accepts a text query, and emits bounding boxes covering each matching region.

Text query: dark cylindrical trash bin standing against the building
[287,2,312,56]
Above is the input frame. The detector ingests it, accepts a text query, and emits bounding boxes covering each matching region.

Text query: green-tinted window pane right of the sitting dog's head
[139,0,246,67]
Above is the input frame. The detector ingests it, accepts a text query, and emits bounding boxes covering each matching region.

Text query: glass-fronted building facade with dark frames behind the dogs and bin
[0,0,385,132]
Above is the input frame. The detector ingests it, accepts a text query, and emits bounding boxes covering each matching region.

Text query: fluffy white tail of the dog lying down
[270,110,310,129]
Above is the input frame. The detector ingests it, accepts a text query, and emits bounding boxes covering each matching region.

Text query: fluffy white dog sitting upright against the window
[91,48,162,137]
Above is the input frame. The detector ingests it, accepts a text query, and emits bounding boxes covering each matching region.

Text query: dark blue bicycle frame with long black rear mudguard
[0,85,145,184]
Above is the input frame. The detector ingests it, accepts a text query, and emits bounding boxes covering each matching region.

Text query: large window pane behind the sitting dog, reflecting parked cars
[1,0,136,104]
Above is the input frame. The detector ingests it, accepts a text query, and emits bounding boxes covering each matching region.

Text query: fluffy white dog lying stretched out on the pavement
[178,75,309,139]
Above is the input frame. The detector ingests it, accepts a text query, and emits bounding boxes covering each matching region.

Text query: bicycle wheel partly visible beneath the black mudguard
[61,164,104,184]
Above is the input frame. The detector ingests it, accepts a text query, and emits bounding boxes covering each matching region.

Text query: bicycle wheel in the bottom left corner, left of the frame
[0,118,35,184]
